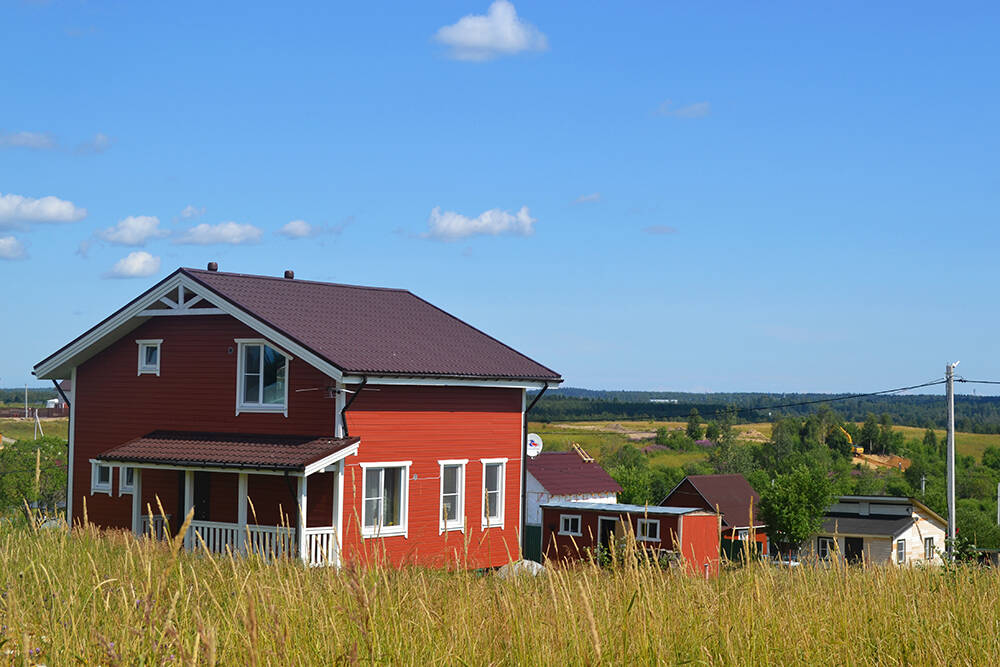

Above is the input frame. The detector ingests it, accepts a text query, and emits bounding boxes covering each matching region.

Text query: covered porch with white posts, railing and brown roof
[94,431,359,565]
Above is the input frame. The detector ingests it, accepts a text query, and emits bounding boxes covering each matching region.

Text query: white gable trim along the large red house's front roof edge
[35,272,343,380]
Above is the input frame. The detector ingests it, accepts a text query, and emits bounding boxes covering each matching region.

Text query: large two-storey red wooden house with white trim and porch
[34,263,562,567]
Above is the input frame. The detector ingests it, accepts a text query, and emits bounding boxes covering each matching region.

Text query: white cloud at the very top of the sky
[434,0,549,62]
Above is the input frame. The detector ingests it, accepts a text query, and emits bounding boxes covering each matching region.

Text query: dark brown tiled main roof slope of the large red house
[181,269,560,380]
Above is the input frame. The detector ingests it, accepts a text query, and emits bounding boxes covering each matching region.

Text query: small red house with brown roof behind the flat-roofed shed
[660,474,768,558]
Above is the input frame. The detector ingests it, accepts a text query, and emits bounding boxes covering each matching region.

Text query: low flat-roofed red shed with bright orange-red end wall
[541,501,721,576]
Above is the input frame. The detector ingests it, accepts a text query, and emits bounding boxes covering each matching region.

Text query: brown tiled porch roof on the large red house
[96,431,360,472]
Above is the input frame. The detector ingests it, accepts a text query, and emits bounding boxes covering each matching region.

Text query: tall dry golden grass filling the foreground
[0,526,1000,665]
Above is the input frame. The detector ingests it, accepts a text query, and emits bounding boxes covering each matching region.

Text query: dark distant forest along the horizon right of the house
[529,385,1000,433]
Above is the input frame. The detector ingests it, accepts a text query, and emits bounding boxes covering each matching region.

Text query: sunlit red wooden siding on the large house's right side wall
[344,386,522,567]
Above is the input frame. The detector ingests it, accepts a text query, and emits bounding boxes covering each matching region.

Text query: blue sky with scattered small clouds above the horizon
[0,0,1000,392]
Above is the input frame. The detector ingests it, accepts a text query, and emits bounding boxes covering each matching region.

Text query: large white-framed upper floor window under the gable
[236,340,291,416]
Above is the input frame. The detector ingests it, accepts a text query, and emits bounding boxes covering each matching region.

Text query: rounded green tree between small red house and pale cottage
[760,466,833,553]
